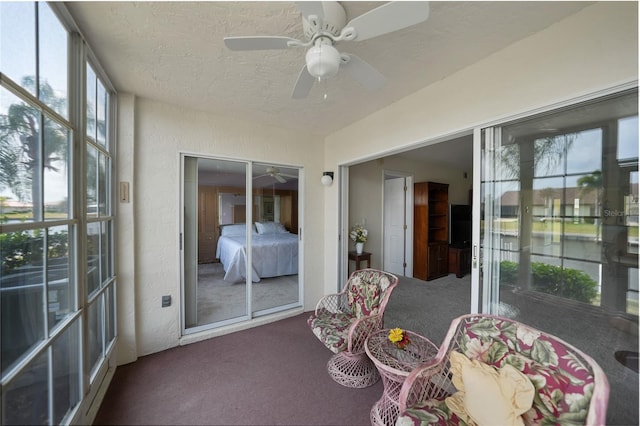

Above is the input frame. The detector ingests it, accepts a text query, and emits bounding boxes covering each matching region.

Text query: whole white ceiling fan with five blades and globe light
[224,1,429,99]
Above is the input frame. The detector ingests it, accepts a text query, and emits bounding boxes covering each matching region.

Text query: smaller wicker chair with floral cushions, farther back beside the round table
[307,269,398,388]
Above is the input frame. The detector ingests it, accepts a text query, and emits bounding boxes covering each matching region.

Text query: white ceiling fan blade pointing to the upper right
[343,1,429,41]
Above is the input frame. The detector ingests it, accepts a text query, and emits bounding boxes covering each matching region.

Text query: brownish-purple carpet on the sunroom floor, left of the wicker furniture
[94,313,382,425]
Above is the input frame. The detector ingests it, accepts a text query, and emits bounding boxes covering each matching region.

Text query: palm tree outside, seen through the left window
[0,77,69,218]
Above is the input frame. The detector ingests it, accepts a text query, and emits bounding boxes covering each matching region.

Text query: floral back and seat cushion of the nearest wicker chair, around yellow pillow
[397,318,595,426]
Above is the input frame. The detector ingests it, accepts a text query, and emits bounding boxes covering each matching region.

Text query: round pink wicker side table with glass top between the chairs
[365,329,438,426]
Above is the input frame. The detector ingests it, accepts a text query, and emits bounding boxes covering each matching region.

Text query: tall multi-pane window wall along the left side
[0,2,116,424]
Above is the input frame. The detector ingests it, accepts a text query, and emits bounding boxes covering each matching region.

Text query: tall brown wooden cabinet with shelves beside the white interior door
[413,182,449,280]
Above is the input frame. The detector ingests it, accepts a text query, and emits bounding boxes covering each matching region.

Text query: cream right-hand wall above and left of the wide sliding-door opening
[324,2,638,292]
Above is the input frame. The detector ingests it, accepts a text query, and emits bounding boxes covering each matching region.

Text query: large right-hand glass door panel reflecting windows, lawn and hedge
[480,90,638,424]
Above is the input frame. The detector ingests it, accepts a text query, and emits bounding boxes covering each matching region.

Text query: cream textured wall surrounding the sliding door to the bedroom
[118,95,324,356]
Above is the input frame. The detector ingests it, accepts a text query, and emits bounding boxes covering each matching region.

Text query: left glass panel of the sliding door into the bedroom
[183,156,249,331]
